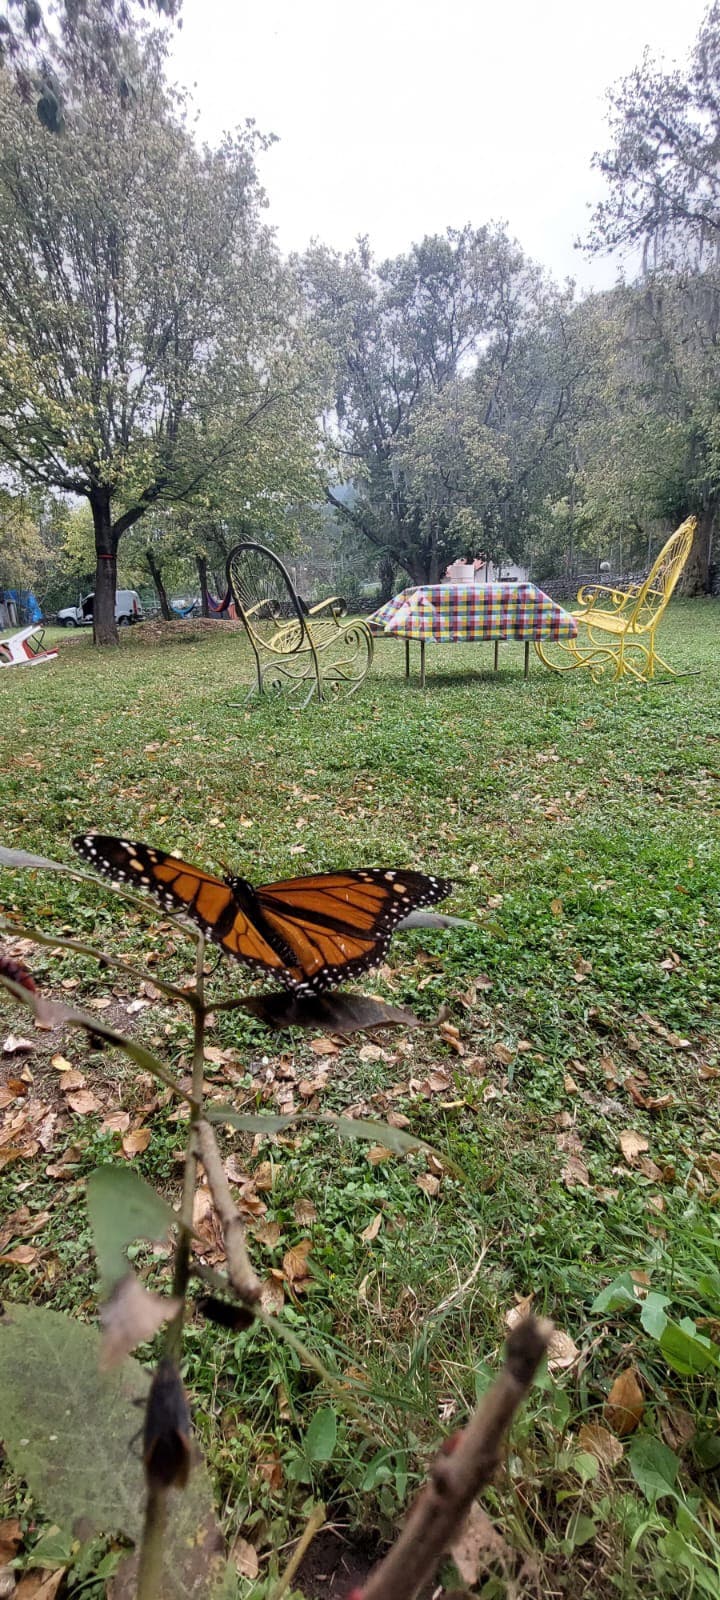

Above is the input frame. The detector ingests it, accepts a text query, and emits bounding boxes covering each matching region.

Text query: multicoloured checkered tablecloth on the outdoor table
[368,584,578,645]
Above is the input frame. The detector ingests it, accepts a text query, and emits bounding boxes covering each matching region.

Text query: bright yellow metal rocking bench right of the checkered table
[534,517,698,683]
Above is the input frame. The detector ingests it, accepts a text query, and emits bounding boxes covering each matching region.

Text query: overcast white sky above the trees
[173,0,706,286]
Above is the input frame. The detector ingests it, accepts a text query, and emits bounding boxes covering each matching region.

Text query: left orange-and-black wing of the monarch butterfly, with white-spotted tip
[72,834,293,976]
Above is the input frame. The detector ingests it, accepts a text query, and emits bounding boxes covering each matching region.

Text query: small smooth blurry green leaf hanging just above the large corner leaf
[88,1166,178,1294]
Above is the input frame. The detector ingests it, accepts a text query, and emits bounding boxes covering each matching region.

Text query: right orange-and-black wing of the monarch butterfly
[254,869,453,994]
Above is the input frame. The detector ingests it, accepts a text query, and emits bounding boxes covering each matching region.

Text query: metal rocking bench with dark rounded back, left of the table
[227,541,373,706]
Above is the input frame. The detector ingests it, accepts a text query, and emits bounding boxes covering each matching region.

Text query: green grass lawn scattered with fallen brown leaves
[0,602,720,1600]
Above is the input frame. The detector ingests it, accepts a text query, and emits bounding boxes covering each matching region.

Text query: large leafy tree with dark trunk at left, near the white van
[0,12,323,642]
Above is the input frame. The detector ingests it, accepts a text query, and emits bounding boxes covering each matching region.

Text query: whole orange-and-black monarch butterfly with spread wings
[72,834,453,995]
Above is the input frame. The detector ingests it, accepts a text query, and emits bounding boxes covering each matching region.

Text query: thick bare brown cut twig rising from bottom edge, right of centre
[362,1317,552,1600]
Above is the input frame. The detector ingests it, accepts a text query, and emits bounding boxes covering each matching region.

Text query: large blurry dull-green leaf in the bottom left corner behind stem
[0,1306,226,1600]
